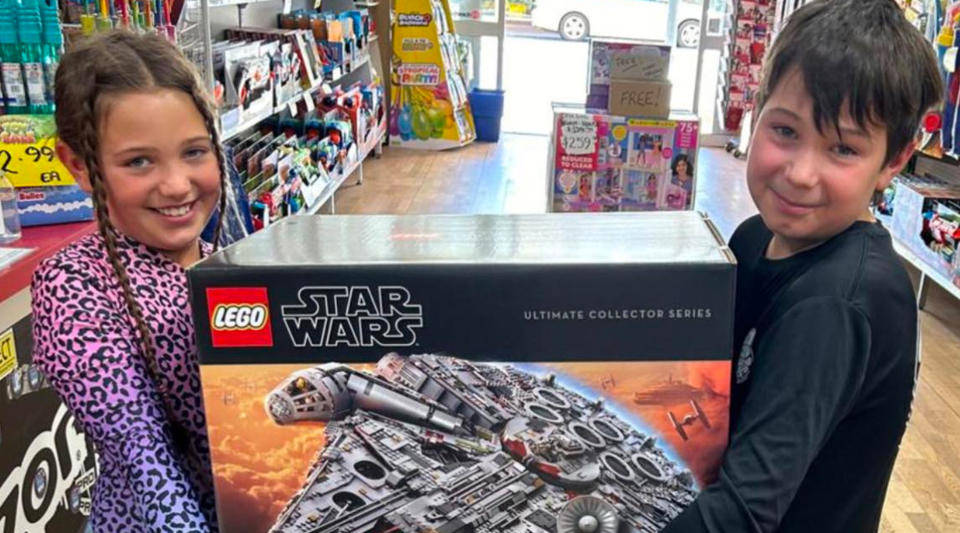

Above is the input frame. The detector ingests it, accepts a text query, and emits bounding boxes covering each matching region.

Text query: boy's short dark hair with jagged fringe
[757,0,943,165]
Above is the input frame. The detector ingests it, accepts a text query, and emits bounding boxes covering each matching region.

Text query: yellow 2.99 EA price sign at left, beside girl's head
[0,115,75,187]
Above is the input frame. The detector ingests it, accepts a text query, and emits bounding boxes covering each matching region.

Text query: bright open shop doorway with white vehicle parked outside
[496,0,703,135]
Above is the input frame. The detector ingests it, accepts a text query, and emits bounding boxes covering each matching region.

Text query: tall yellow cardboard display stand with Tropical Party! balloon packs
[389,0,476,149]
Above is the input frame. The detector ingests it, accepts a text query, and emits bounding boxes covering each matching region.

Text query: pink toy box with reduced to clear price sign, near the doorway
[548,105,699,212]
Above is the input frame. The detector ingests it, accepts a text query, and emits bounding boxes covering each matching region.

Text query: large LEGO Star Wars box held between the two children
[189,212,735,533]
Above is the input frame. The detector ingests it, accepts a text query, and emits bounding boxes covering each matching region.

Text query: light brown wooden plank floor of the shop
[336,135,960,533]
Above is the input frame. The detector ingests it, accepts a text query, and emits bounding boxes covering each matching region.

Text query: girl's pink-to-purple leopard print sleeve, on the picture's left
[31,239,209,533]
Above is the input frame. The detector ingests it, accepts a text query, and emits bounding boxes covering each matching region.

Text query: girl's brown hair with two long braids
[55,31,226,394]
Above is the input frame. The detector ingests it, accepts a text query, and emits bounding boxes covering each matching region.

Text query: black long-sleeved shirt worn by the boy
[664,216,919,533]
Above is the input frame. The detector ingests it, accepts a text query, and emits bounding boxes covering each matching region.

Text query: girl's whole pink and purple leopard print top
[32,234,217,533]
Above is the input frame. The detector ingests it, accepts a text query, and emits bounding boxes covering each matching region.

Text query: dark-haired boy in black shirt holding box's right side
[665,0,942,533]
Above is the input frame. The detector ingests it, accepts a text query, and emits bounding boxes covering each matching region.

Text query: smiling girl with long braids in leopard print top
[32,32,225,533]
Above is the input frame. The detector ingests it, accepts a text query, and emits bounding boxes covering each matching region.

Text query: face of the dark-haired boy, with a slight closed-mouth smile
[747,70,914,257]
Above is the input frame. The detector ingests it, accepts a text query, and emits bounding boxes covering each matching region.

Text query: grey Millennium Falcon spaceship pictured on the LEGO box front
[264,353,697,533]
